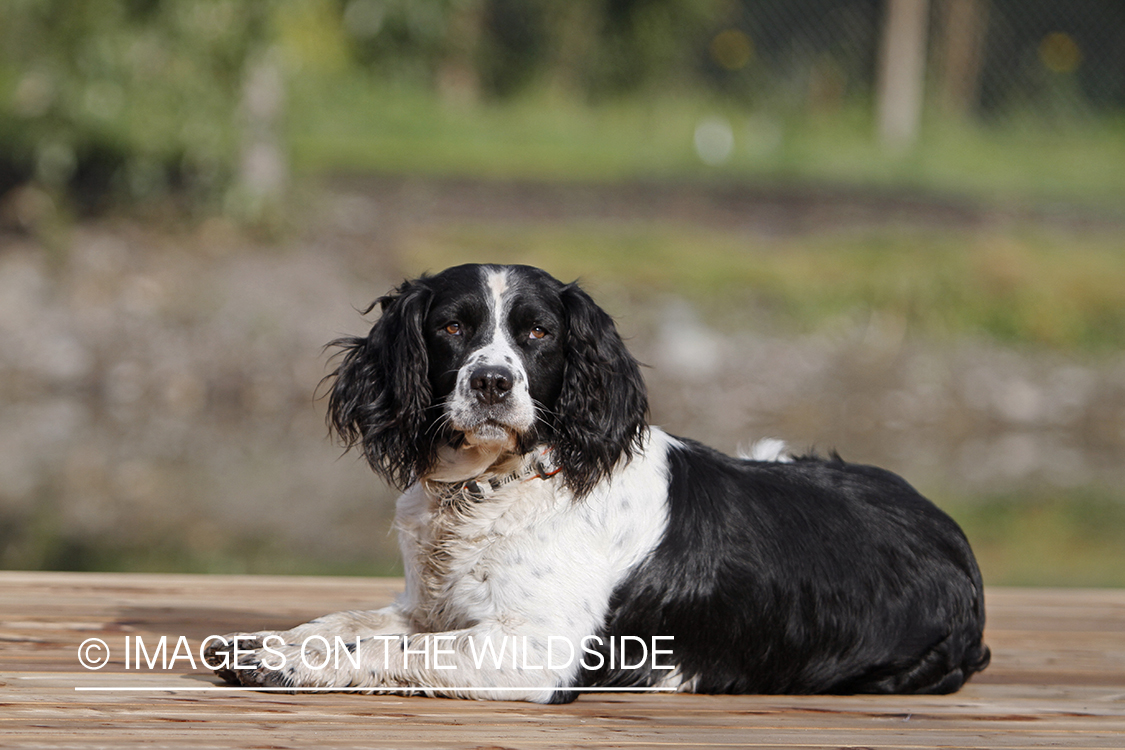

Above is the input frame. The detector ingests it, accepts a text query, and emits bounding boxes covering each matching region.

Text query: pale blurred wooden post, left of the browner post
[876,0,929,152]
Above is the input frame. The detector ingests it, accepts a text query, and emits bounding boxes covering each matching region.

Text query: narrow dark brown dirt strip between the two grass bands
[327,177,1125,235]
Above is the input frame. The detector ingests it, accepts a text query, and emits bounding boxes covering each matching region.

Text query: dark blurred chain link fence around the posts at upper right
[701,0,1125,134]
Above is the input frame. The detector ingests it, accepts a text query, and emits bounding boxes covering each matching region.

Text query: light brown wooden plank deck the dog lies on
[0,572,1125,750]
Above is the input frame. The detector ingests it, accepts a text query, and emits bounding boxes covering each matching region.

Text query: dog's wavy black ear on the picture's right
[552,283,648,496]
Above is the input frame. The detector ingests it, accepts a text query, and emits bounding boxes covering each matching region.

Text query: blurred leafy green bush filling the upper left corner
[0,0,271,208]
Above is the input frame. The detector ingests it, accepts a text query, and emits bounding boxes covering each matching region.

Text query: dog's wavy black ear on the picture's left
[325,280,435,488]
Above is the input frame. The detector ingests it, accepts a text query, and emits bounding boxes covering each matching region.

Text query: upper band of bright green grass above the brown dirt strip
[289,73,1125,214]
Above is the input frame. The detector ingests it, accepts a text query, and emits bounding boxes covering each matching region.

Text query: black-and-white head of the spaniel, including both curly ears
[329,265,647,496]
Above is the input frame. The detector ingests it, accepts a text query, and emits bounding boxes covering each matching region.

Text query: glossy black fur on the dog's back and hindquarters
[587,441,989,694]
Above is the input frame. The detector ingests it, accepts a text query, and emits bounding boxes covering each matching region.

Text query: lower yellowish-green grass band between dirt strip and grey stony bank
[401,223,1125,351]
